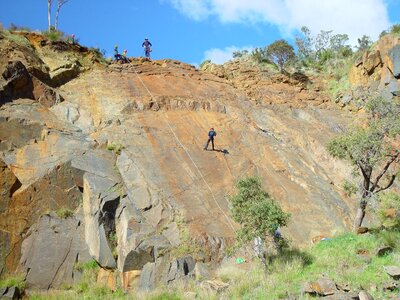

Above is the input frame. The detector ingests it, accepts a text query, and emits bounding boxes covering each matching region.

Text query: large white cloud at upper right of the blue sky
[168,0,390,41]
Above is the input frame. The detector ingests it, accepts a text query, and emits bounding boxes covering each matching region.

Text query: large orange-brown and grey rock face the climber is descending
[0,34,354,289]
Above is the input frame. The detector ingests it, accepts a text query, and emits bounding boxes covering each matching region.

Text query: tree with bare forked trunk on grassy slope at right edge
[327,96,400,230]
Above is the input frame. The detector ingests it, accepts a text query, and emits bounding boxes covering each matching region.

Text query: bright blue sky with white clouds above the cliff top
[0,0,400,64]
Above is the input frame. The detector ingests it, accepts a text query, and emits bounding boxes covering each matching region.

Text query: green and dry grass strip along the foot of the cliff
[25,230,400,300]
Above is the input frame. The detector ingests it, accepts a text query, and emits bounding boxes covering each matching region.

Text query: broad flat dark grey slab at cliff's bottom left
[20,214,90,289]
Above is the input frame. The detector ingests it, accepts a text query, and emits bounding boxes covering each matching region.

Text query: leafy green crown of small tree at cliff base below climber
[230,177,289,242]
